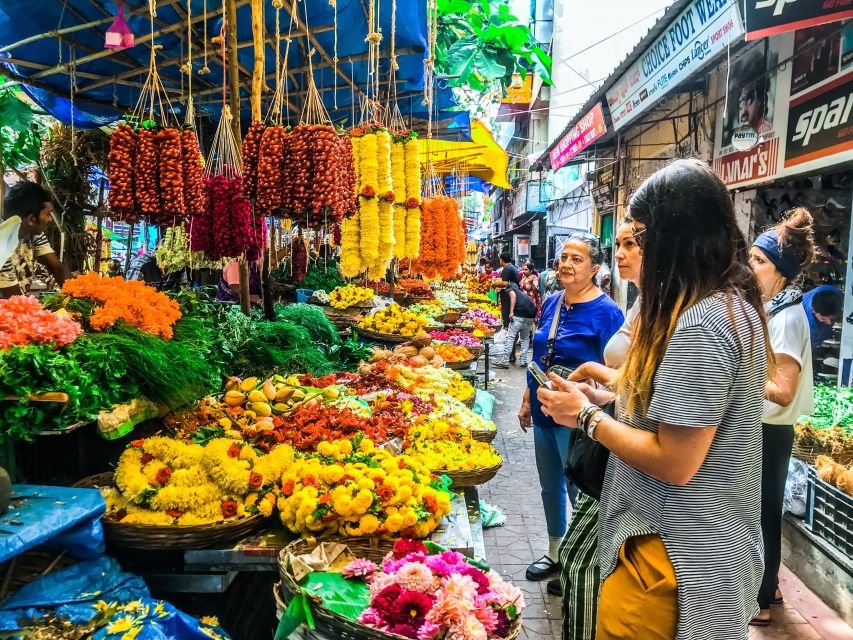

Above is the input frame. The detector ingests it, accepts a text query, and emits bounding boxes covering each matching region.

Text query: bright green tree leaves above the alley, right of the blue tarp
[436,0,551,90]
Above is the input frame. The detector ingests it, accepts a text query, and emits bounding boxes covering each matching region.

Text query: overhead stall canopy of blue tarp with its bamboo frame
[0,0,454,128]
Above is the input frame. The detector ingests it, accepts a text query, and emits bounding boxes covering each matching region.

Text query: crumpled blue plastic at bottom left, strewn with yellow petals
[0,556,228,640]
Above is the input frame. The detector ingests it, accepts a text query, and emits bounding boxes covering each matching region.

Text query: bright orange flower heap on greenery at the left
[62,271,181,340]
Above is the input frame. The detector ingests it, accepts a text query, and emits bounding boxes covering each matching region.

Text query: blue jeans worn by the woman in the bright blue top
[533,425,577,538]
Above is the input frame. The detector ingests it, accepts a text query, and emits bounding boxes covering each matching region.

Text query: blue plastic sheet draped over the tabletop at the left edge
[0,484,106,562]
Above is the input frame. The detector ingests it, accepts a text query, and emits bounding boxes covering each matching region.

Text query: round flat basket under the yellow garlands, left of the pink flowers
[74,472,267,550]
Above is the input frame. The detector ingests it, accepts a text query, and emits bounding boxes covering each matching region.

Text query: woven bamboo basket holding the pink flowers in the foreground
[276,538,521,640]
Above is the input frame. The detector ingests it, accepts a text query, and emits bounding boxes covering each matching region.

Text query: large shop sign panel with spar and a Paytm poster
[714,21,853,188]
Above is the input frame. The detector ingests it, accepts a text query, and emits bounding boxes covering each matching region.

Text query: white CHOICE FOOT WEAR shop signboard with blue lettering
[607,0,744,131]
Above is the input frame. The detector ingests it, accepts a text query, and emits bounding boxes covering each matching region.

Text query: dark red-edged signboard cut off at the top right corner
[744,0,853,40]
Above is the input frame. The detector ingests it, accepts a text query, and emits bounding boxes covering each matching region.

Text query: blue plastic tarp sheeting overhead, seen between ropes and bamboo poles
[0,0,455,128]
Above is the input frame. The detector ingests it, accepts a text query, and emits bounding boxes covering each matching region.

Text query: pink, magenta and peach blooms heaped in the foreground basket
[344,540,524,640]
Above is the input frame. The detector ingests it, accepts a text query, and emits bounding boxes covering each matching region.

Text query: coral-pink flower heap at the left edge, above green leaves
[0,296,83,351]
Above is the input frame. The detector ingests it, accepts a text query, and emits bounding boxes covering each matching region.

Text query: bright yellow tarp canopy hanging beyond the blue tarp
[419,120,512,189]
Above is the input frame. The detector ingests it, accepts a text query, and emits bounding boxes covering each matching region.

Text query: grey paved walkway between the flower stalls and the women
[480,365,853,640]
